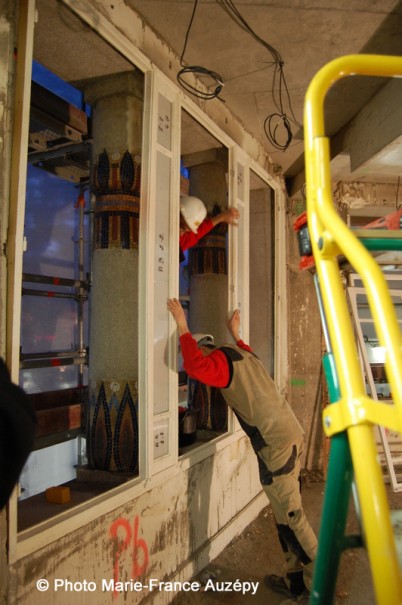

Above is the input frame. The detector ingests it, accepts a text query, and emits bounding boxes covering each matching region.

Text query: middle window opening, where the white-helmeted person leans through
[178,110,230,454]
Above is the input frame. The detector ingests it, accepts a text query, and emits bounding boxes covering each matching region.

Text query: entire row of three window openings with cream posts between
[13,0,275,540]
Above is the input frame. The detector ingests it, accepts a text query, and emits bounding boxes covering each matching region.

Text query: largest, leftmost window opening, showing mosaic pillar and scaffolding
[18,0,144,530]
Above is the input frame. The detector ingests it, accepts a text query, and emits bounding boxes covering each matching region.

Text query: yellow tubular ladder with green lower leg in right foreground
[304,55,402,605]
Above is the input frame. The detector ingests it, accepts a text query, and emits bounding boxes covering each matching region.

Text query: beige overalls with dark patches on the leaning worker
[220,345,317,590]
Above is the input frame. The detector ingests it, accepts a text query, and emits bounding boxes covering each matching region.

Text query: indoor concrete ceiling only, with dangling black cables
[125,0,402,190]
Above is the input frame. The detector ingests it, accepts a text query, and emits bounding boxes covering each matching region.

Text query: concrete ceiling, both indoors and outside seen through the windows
[34,0,402,194]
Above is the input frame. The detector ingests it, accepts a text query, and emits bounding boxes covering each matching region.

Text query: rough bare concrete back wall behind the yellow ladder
[288,182,402,470]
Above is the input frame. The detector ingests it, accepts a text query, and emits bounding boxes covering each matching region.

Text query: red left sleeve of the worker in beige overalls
[180,332,229,388]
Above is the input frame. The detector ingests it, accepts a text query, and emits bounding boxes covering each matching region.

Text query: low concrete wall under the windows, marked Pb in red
[7,437,267,605]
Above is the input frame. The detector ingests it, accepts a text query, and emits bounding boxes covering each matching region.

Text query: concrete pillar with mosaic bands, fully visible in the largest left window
[85,71,143,473]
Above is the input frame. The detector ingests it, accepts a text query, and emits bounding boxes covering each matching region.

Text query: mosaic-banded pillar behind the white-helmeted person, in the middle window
[189,155,231,431]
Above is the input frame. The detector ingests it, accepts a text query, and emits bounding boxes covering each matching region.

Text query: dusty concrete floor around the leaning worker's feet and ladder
[173,474,402,605]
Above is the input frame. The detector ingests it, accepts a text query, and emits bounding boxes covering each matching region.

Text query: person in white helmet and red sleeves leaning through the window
[180,195,240,262]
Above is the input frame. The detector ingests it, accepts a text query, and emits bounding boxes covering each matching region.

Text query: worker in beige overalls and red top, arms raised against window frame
[167,298,317,599]
